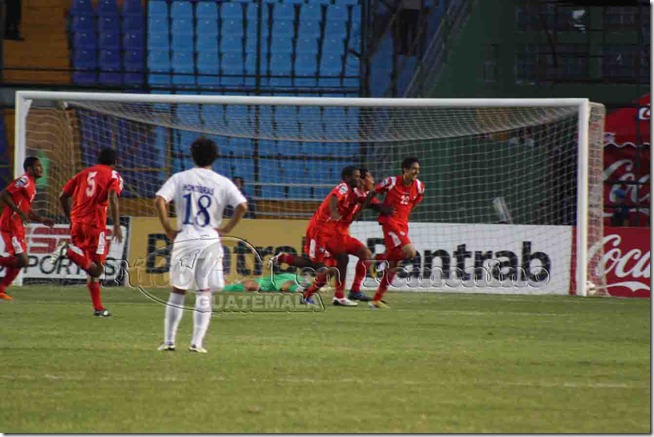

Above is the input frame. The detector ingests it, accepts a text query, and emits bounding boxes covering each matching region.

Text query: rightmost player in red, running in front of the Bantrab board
[362,157,425,308]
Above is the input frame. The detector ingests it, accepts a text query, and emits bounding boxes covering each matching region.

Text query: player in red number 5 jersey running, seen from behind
[53,148,123,317]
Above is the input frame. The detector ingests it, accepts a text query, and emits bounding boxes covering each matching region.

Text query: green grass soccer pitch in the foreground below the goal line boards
[0,287,651,433]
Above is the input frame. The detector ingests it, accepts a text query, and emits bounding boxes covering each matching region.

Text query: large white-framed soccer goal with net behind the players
[15,91,604,296]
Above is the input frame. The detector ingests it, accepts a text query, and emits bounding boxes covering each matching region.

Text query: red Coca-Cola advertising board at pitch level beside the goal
[590,227,651,297]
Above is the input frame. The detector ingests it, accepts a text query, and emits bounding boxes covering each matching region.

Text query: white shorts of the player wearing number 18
[170,238,225,291]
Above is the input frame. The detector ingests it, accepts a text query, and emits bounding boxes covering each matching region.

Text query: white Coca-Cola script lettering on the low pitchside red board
[589,234,651,292]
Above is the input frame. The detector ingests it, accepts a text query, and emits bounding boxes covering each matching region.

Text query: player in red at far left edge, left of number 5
[0,156,54,300]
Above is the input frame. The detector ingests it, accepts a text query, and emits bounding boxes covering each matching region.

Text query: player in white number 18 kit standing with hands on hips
[155,137,248,353]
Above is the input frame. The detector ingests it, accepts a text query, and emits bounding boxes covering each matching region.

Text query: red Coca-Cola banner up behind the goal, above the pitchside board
[604,94,650,226]
